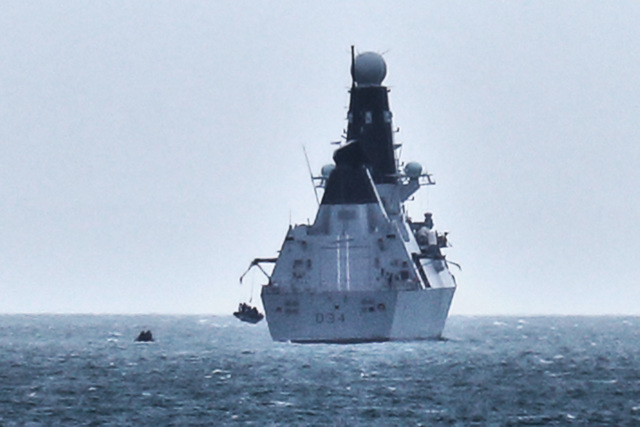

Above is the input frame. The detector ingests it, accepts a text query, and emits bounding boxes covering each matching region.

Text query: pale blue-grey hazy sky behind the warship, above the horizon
[0,0,640,315]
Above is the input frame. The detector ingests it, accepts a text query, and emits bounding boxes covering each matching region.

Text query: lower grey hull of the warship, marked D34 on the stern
[262,287,455,343]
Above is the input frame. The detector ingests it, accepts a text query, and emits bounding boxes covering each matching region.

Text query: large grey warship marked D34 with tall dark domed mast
[240,47,456,343]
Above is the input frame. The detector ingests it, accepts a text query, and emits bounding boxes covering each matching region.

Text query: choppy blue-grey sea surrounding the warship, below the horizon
[0,315,640,426]
